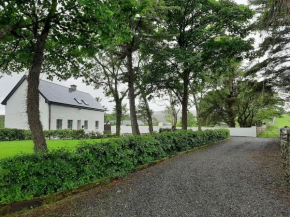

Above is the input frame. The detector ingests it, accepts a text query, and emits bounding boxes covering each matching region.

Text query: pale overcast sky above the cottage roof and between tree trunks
[0,0,248,115]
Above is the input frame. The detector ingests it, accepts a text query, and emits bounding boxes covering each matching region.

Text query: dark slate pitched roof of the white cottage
[2,76,104,111]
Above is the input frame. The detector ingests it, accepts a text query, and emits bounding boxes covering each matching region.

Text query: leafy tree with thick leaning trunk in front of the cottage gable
[0,0,112,151]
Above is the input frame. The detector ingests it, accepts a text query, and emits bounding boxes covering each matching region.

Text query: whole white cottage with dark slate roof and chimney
[2,76,104,132]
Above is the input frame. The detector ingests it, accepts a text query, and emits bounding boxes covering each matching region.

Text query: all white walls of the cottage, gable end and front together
[5,80,104,132]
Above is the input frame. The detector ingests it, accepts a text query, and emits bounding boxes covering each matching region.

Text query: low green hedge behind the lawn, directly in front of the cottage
[0,128,114,141]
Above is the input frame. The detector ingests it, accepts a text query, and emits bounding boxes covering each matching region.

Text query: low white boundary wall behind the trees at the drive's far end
[111,126,257,137]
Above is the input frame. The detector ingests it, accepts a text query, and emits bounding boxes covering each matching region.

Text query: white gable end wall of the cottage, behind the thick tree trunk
[5,81,48,129]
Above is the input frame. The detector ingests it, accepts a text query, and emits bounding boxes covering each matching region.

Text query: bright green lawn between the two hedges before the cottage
[0,139,109,159]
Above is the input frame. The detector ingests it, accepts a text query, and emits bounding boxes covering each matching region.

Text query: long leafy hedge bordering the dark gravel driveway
[0,130,229,203]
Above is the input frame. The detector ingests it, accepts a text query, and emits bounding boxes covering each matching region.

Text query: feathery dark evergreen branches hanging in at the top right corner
[248,0,290,91]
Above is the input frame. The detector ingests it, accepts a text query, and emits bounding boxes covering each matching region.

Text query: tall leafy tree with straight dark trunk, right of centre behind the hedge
[148,0,253,130]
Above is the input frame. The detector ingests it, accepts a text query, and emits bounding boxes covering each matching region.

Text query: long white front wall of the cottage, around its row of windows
[51,105,104,132]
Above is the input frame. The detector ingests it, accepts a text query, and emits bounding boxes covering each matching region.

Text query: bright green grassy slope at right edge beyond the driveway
[259,114,290,138]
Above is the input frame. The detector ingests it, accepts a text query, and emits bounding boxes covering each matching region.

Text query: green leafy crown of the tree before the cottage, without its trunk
[0,0,120,78]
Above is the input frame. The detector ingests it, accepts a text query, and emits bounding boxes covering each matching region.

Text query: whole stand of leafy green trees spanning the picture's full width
[0,0,290,146]
